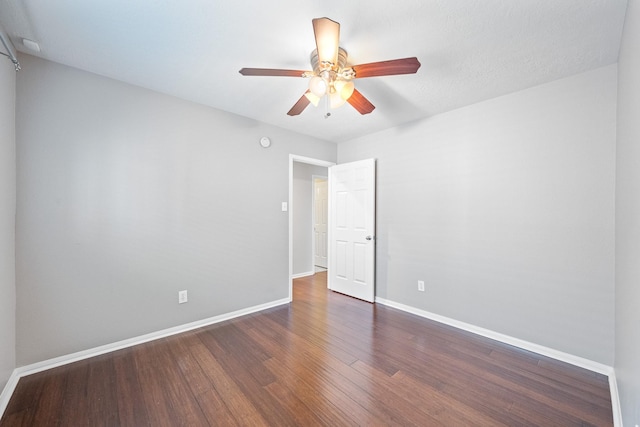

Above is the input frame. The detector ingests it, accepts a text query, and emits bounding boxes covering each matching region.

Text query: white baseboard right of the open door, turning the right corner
[376,297,622,427]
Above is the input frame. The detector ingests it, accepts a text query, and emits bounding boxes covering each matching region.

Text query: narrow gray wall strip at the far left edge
[0,51,16,391]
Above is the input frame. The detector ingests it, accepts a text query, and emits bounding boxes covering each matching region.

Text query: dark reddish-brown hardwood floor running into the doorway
[0,273,613,426]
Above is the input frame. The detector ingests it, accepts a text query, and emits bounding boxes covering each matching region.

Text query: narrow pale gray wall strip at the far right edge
[615,1,640,426]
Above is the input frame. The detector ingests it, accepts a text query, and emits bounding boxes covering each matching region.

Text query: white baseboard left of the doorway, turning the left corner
[0,298,290,418]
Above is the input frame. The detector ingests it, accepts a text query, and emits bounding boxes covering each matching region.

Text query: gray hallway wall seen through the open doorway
[292,162,328,275]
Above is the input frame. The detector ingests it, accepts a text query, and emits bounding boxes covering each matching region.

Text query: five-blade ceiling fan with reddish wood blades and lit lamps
[240,18,420,117]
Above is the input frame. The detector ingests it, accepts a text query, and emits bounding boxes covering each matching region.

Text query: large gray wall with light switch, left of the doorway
[16,56,336,365]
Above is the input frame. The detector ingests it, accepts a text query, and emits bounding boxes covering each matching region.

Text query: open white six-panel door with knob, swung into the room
[328,159,376,302]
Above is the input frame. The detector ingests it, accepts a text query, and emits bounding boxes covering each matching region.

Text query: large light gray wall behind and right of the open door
[338,65,617,365]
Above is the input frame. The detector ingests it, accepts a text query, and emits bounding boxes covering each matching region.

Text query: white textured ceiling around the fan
[0,0,627,142]
